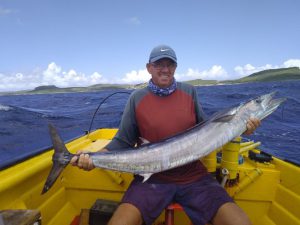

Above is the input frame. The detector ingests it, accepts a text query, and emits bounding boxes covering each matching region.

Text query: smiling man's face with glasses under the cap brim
[147,58,177,88]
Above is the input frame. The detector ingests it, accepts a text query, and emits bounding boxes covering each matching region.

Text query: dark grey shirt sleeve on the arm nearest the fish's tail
[105,93,139,151]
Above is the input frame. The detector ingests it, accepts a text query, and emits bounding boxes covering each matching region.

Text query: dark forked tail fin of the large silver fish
[42,124,73,194]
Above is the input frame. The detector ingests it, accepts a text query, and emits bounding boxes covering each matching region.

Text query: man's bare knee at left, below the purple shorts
[108,203,143,225]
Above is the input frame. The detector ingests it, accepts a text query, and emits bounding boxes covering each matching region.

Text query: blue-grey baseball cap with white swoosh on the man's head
[149,45,177,63]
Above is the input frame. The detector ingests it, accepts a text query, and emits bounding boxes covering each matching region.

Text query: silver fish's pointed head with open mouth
[245,92,286,120]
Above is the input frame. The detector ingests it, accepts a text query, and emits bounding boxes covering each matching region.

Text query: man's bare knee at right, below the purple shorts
[212,202,251,225]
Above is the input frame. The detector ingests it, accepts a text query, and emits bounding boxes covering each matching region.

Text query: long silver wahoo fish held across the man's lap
[42,92,286,194]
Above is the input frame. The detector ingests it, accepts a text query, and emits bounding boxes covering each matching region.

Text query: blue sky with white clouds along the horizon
[0,0,300,92]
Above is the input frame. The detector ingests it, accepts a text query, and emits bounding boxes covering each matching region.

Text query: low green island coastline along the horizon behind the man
[0,67,300,95]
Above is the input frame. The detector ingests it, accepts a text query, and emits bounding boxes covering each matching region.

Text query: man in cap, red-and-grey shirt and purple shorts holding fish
[71,45,260,225]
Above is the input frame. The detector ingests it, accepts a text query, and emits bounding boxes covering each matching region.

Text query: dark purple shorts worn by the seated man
[122,174,233,225]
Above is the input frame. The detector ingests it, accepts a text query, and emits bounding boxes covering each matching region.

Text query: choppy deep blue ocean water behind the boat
[0,81,300,168]
